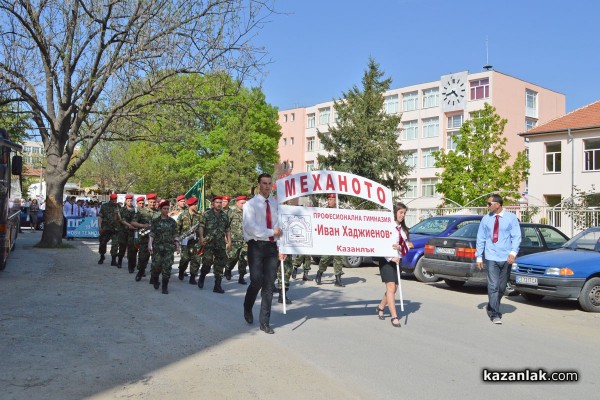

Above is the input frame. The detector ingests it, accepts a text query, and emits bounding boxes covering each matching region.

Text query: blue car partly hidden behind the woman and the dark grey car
[342,215,482,282]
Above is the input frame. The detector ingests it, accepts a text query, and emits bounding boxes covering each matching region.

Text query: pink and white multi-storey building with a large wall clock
[277,70,566,212]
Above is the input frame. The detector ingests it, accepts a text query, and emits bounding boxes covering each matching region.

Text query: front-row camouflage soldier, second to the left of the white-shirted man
[198,196,231,293]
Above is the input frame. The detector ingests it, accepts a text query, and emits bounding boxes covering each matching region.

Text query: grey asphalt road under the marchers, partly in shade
[0,231,600,400]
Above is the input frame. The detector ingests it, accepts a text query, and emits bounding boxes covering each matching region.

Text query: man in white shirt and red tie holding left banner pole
[242,173,286,334]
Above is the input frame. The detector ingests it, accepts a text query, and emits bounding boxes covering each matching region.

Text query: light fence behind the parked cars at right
[406,204,600,237]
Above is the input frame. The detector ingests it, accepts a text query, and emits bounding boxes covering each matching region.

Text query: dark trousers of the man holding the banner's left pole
[244,240,279,325]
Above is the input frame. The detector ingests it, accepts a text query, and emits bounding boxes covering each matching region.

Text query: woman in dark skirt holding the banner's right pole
[376,203,411,328]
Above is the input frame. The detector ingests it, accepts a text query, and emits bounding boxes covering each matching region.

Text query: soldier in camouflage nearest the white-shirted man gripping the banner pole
[225,196,248,285]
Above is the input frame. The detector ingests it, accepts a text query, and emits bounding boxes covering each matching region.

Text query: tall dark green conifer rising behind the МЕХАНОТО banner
[317,58,410,206]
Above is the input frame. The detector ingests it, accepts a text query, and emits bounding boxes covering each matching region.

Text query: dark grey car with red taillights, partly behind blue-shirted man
[422,223,569,288]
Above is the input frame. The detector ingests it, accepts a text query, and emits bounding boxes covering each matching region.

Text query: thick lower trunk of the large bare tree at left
[40,174,66,247]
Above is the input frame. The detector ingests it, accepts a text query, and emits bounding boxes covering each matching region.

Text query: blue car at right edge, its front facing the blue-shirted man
[510,226,600,312]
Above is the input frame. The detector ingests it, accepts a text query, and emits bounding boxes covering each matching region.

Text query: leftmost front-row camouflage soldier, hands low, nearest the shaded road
[148,200,180,294]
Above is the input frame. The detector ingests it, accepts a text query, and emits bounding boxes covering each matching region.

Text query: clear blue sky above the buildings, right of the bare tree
[255,0,600,112]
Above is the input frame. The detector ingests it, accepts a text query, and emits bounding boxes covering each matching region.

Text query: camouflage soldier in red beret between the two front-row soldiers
[177,197,202,285]
